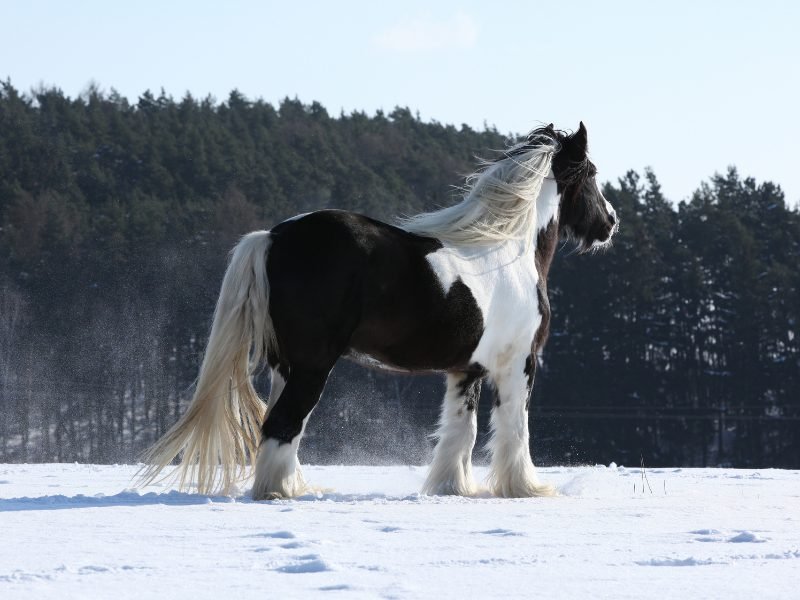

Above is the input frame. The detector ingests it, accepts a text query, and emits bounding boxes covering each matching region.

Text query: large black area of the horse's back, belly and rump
[267,211,483,370]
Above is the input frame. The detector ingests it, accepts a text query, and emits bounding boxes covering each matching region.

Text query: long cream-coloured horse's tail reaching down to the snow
[139,231,277,494]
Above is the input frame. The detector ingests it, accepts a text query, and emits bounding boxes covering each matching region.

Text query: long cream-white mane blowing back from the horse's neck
[400,128,560,245]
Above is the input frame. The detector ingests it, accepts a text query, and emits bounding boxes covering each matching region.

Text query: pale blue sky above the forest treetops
[0,0,800,205]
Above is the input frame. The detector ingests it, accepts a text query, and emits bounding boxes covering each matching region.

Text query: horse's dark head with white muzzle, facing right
[545,122,619,251]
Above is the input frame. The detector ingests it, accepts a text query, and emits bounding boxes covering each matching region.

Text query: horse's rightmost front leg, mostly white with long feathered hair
[488,355,555,498]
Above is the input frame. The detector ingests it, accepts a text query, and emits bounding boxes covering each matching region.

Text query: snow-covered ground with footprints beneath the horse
[0,464,800,600]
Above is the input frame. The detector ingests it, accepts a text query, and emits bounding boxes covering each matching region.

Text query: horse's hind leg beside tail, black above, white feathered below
[253,365,330,500]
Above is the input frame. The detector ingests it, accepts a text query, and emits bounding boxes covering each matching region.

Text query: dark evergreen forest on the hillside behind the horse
[0,81,800,468]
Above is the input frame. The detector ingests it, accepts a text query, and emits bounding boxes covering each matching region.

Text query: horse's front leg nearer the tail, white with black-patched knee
[422,368,485,496]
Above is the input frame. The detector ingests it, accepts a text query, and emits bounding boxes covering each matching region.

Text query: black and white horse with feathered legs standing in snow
[140,122,619,500]
